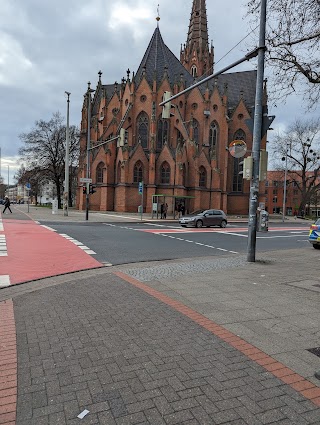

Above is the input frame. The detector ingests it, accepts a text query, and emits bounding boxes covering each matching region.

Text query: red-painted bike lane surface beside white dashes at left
[0,219,103,285]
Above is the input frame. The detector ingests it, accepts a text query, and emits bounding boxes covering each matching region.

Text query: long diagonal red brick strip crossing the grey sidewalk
[114,272,320,407]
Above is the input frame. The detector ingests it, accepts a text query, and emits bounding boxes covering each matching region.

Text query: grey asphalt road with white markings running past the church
[38,221,311,265]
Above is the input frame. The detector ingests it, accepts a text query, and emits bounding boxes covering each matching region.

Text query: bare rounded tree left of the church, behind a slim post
[19,112,80,208]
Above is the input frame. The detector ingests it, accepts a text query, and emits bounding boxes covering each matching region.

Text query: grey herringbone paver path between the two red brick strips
[8,271,320,425]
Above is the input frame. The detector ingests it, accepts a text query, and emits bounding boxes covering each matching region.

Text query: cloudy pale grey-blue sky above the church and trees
[0,0,319,184]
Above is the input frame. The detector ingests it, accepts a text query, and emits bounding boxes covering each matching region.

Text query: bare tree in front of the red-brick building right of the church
[269,119,320,213]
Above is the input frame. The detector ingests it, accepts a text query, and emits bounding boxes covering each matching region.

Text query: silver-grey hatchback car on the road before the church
[179,210,228,227]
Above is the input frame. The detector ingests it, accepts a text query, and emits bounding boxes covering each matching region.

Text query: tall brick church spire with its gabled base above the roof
[180,0,214,77]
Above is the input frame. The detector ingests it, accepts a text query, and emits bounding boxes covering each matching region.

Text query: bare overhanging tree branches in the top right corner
[248,0,320,108]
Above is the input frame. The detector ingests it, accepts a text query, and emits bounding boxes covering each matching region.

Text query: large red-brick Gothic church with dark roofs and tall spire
[77,0,266,215]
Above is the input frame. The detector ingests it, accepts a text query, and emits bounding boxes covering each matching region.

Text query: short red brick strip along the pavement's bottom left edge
[0,300,17,425]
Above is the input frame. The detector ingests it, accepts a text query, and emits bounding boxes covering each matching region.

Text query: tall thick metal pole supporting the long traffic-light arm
[247,0,267,262]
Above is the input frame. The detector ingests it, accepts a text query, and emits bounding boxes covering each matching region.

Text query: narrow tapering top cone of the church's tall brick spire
[186,0,209,50]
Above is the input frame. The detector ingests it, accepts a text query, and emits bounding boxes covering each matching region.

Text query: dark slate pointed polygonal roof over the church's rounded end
[135,26,194,86]
